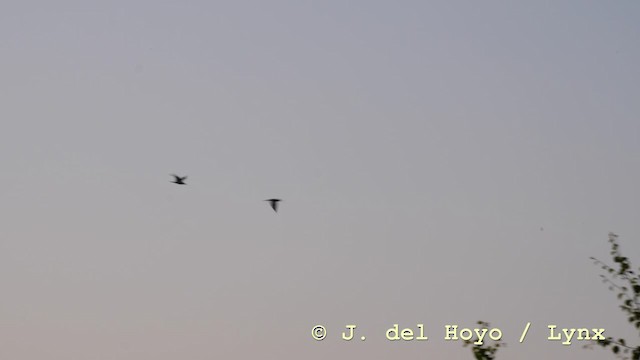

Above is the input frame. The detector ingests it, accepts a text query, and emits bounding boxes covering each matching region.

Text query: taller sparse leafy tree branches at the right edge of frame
[591,233,640,360]
